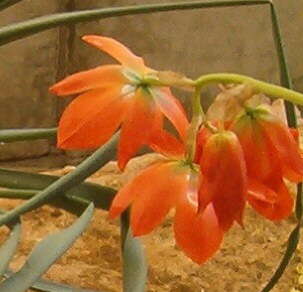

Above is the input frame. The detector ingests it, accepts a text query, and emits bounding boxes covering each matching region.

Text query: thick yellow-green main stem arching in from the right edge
[195,73,303,105]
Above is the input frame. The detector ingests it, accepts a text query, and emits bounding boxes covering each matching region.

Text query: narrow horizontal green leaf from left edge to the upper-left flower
[0,128,57,143]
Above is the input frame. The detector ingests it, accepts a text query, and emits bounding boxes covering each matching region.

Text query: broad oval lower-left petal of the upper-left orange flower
[58,88,125,149]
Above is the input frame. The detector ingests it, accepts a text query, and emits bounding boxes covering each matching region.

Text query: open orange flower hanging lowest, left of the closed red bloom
[109,160,223,264]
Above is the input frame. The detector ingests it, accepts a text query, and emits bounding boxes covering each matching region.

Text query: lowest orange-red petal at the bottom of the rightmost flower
[247,179,294,221]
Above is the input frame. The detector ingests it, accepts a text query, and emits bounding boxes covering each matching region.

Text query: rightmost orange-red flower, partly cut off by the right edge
[231,106,303,220]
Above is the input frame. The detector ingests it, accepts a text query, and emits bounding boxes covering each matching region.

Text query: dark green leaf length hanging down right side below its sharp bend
[261,3,302,292]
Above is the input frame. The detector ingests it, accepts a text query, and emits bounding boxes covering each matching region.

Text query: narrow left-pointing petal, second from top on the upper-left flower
[49,65,126,95]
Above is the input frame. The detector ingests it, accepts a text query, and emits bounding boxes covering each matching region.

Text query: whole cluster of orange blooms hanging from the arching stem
[50,36,303,264]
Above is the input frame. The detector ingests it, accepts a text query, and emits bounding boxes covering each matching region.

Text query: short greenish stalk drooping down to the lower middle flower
[186,86,205,162]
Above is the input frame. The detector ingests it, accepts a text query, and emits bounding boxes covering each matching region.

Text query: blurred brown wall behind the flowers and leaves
[0,0,303,167]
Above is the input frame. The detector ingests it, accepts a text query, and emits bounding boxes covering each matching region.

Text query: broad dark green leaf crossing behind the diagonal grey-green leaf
[0,168,116,214]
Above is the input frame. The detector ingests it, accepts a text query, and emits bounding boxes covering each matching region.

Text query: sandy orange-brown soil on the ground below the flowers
[0,154,303,292]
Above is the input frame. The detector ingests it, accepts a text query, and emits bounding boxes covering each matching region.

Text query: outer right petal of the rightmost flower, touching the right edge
[260,120,303,182]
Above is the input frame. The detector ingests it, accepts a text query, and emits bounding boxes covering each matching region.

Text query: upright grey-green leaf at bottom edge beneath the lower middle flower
[121,212,147,292]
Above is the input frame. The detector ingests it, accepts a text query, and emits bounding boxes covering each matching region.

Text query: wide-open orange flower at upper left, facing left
[50,35,188,169]
